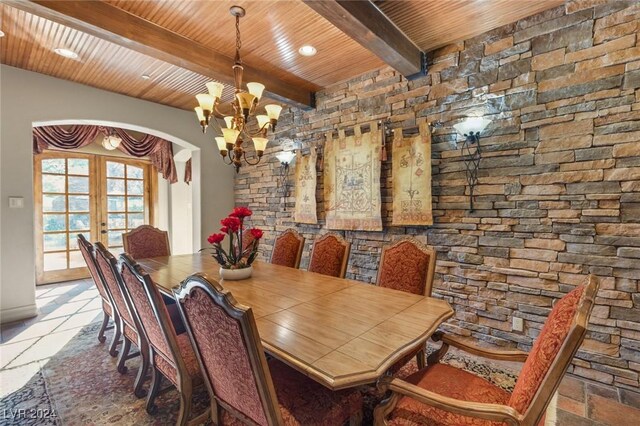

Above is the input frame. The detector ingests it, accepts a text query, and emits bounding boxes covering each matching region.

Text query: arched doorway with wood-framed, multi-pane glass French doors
[34,120,199,284]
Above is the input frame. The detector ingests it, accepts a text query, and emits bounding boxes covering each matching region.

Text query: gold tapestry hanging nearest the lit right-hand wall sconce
[391,121,433,225]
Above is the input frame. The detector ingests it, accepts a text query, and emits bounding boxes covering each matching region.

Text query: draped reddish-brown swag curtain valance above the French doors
[33,126,178,183]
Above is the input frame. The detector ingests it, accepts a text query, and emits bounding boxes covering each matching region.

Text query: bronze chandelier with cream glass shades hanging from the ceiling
[195,6,282,172]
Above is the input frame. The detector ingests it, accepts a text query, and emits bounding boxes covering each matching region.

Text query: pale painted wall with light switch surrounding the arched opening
[0,65,233,322]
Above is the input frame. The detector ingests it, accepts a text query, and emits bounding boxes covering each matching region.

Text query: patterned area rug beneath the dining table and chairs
[0,323,516,426]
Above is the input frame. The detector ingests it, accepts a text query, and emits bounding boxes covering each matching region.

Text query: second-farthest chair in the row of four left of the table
[95,242,149,398]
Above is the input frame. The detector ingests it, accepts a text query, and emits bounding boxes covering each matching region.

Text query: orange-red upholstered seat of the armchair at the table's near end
[388,364,511,426]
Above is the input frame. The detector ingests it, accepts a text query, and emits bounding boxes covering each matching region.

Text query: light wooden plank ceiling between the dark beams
[0,0,562,109]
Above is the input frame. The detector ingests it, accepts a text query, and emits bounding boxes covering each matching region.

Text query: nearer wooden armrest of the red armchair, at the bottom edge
[378,379,521,426]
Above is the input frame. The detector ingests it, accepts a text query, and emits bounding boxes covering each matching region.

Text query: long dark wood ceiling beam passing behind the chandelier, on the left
[0,0,319,108]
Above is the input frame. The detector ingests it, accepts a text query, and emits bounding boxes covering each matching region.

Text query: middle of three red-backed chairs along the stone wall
[309,233,351,278]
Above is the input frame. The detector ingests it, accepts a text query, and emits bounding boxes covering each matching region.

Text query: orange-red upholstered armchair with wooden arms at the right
[375,275,599,426]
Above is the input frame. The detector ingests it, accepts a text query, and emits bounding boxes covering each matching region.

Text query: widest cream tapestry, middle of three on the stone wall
[324,122,382,231]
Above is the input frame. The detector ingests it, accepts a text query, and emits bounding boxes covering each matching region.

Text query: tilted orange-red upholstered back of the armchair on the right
[508,275,600,425]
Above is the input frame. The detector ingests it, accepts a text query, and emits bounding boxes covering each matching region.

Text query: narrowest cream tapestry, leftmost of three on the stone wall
[293,147,318,224]
